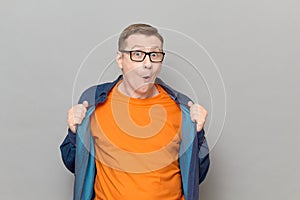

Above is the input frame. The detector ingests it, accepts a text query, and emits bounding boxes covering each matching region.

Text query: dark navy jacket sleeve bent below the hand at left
[60,129,76,173]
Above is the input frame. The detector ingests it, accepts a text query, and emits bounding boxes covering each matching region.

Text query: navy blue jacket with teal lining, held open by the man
[60,76,210,200]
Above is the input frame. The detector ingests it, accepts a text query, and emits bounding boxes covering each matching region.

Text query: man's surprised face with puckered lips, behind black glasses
[116,34,162,95]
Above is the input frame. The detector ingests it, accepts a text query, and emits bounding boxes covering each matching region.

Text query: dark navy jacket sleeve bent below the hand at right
[198,129,210,184]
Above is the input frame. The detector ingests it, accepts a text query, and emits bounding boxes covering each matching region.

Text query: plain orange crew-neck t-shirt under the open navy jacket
[91,81,184,200]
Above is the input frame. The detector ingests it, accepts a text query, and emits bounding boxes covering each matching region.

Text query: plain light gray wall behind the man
[0,0,300,200]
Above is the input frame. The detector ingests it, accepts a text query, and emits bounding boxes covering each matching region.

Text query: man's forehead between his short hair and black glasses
[126,34,162,49]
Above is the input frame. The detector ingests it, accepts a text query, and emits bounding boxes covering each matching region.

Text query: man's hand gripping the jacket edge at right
[188,101,208,132]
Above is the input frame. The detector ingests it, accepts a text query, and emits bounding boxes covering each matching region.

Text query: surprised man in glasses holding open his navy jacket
[60,24,210,200]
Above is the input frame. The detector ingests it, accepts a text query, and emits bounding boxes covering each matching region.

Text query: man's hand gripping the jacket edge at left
[68,101,89,133]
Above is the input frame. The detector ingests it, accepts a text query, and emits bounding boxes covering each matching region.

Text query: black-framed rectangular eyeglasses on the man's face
[119,50,165,63]
